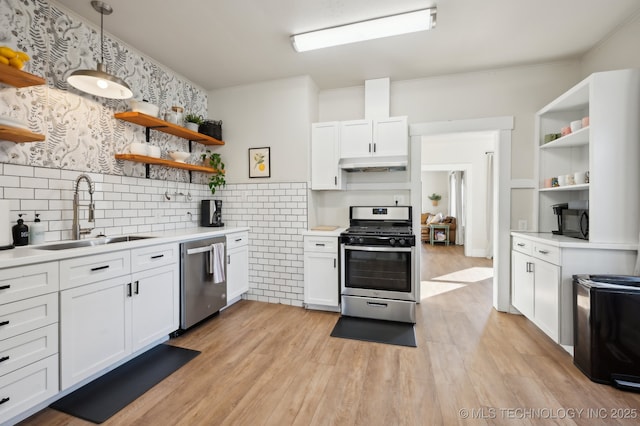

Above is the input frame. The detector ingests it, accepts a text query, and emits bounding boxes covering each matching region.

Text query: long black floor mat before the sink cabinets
[50,345,200,423]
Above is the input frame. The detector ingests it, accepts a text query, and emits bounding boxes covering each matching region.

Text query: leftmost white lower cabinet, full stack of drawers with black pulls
[0,262,60,424]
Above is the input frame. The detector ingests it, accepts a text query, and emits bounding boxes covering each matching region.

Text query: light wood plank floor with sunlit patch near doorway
[23,244,640,426]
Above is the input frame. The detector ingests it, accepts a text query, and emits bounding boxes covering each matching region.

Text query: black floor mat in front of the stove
[331,316,418,348]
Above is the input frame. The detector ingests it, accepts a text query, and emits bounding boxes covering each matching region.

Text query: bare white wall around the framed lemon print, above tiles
[208,76,318,183]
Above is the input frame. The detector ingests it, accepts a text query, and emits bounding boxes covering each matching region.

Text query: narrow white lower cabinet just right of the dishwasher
[227,232,249,306]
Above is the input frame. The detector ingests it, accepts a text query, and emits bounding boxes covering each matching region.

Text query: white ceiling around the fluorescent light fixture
[55,0,640,90]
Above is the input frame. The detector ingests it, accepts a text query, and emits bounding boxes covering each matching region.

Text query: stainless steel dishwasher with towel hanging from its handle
[180,236,227,330]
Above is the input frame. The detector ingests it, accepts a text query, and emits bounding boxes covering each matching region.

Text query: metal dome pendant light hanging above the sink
[67,0,133,99]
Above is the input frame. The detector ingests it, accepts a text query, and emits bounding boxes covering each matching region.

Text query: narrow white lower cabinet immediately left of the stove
[304,236,340,311]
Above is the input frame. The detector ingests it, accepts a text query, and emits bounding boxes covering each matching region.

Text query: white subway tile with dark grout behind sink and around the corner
[0,164,308,306]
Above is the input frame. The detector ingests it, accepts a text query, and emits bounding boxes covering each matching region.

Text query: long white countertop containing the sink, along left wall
[0,227,249,269]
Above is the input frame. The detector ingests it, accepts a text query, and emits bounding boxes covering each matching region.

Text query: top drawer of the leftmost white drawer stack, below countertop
[0,262,60,304]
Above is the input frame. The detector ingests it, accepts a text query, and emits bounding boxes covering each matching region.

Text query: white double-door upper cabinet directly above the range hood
[340,117,409,158]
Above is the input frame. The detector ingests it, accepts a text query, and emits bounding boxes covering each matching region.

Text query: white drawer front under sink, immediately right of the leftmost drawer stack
[60,250,131,290]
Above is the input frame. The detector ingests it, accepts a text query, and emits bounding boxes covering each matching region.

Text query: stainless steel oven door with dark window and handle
[340,244,416,301]
